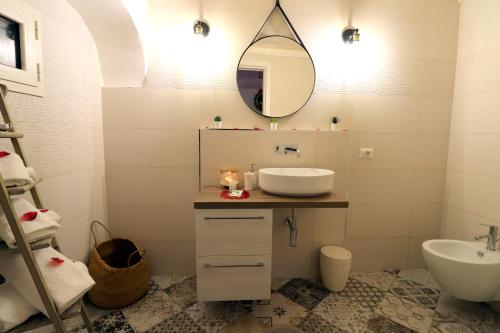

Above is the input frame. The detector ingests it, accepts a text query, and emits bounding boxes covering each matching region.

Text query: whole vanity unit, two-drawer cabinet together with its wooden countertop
[194,187,349,301]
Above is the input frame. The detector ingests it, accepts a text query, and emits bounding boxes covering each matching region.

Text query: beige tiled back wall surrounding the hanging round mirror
[103,0,458,276]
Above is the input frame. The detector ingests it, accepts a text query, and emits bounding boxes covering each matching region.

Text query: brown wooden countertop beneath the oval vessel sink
[194,187,349,209]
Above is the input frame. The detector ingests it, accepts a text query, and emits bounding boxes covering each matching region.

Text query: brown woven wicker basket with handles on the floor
[88,221,149,309]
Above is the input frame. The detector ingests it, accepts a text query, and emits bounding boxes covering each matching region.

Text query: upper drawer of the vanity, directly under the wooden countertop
[196,209,273,256]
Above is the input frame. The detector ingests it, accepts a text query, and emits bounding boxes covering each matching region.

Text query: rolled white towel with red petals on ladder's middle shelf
[0,198,61,249]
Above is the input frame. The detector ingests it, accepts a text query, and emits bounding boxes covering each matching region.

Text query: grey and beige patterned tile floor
[67,270,500,333]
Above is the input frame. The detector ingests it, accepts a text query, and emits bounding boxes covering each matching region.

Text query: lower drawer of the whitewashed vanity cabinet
[196,255,271,301]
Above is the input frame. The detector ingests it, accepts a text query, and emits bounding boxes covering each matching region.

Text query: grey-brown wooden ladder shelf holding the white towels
[0,85,94,333]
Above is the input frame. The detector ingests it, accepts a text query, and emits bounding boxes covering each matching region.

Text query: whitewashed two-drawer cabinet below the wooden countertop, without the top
[195,209,273,301]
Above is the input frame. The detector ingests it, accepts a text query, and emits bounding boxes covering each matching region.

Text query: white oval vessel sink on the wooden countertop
[259,168,335,197]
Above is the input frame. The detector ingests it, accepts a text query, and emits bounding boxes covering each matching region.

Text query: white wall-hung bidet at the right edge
[422,239,500,302]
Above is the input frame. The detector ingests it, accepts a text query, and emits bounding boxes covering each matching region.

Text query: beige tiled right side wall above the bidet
[442,0,500,240]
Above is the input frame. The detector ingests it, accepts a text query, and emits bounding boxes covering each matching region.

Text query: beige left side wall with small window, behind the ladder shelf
[3,0,106,260]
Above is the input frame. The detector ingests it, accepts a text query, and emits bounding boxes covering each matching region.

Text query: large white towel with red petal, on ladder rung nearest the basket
[0,247,95,315]
